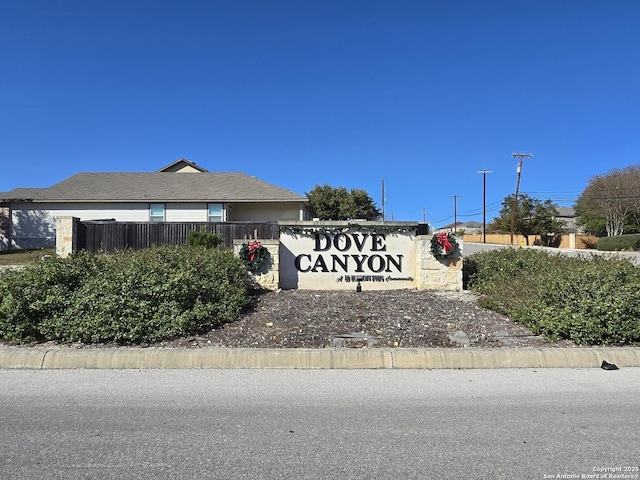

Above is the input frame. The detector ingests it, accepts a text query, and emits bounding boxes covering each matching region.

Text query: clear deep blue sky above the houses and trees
[0,0,640,227]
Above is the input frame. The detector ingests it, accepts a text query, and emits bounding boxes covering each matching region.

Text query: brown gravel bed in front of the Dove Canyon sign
[160,290,573,348]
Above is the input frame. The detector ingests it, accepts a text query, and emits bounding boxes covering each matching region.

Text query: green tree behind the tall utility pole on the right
[490,193,562,245]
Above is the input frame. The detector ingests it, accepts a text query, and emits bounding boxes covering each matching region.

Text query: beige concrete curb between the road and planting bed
[0,346,640,370]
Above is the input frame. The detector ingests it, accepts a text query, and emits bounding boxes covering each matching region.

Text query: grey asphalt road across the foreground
[0,368,640,479]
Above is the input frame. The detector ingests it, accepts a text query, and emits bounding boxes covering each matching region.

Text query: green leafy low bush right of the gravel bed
[465,249,640,345]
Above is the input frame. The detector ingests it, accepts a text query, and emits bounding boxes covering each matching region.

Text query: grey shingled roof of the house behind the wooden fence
[0,171,308,203]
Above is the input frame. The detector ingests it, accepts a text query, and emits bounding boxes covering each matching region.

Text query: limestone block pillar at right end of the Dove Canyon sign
[415,235,463,290]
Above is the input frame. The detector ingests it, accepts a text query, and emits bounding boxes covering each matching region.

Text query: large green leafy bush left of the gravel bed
[0,246,248,344]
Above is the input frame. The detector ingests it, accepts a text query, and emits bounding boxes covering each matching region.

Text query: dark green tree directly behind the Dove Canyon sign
[306,184,381,220]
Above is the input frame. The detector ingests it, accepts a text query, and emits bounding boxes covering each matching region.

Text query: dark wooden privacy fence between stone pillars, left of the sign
[75,221,279,253]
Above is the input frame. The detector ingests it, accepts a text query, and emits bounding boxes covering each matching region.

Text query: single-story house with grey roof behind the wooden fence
[0,158,309,250]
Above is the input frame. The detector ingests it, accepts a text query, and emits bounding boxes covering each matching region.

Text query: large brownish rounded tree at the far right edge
[574,165,640,237]
